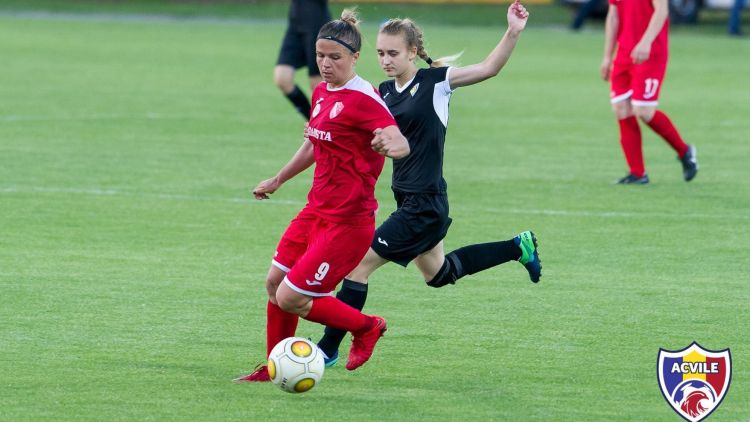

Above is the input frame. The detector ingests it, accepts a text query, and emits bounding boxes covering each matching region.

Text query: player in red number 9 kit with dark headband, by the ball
[235,10,409,382]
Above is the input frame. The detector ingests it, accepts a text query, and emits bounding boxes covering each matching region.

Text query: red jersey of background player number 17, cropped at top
[609,0,669,58]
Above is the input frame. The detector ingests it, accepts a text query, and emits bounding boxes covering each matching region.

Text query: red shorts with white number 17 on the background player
[609,55,667,106]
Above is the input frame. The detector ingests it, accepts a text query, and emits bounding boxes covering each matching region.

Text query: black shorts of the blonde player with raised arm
[371,191,452,267]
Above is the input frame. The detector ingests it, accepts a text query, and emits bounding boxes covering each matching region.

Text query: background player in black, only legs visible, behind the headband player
[273,0,331,120]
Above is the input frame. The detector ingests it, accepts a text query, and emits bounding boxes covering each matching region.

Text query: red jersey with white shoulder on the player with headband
[306,76,396,221]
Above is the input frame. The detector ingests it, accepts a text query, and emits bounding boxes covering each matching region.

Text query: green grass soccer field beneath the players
[0,2,750,421]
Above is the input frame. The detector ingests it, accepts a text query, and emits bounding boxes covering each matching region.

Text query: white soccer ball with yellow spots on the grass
[268,337,325,393]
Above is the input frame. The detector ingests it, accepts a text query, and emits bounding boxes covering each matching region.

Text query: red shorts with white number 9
[272,208,375,296]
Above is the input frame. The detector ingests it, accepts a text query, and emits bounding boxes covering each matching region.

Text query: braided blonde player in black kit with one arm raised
[318,1,542,366]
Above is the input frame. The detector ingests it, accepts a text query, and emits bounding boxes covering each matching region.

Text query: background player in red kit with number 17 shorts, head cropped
[601,0,698,184]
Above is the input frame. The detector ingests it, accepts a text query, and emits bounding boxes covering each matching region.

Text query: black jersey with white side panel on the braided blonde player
[380,67,452,193]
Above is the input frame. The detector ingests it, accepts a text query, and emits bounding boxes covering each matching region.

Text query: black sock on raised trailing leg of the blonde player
[443,239,521,280]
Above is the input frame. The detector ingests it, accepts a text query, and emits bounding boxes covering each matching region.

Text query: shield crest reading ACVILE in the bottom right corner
[656,342,732,422]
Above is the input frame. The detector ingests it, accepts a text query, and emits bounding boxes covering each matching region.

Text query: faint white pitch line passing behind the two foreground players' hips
[0,186,750,220]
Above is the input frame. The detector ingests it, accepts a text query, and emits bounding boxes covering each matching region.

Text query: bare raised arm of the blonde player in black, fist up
[449,0,529,89]
